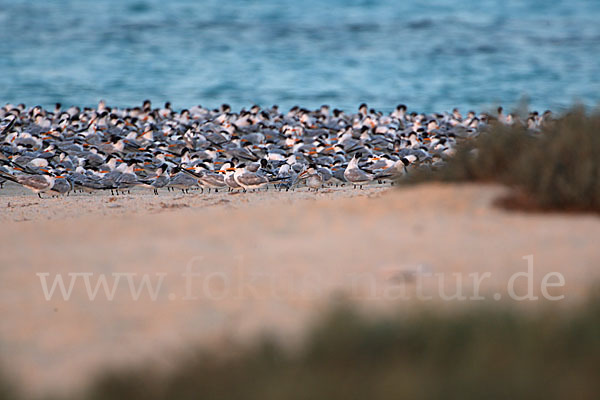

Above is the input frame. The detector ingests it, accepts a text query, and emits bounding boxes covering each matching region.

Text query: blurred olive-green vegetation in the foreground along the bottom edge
[4,298,600,400]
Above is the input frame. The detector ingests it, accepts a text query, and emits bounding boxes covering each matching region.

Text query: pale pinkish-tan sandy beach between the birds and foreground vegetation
[0,184,600,393]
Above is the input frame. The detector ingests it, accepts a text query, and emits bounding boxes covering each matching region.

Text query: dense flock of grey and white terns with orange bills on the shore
[0,100,547,197]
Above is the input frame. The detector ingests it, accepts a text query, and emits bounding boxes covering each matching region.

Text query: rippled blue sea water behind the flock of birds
[0,0,600,111]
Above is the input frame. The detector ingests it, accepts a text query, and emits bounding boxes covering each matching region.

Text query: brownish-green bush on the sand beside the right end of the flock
[404,108,600,212]
